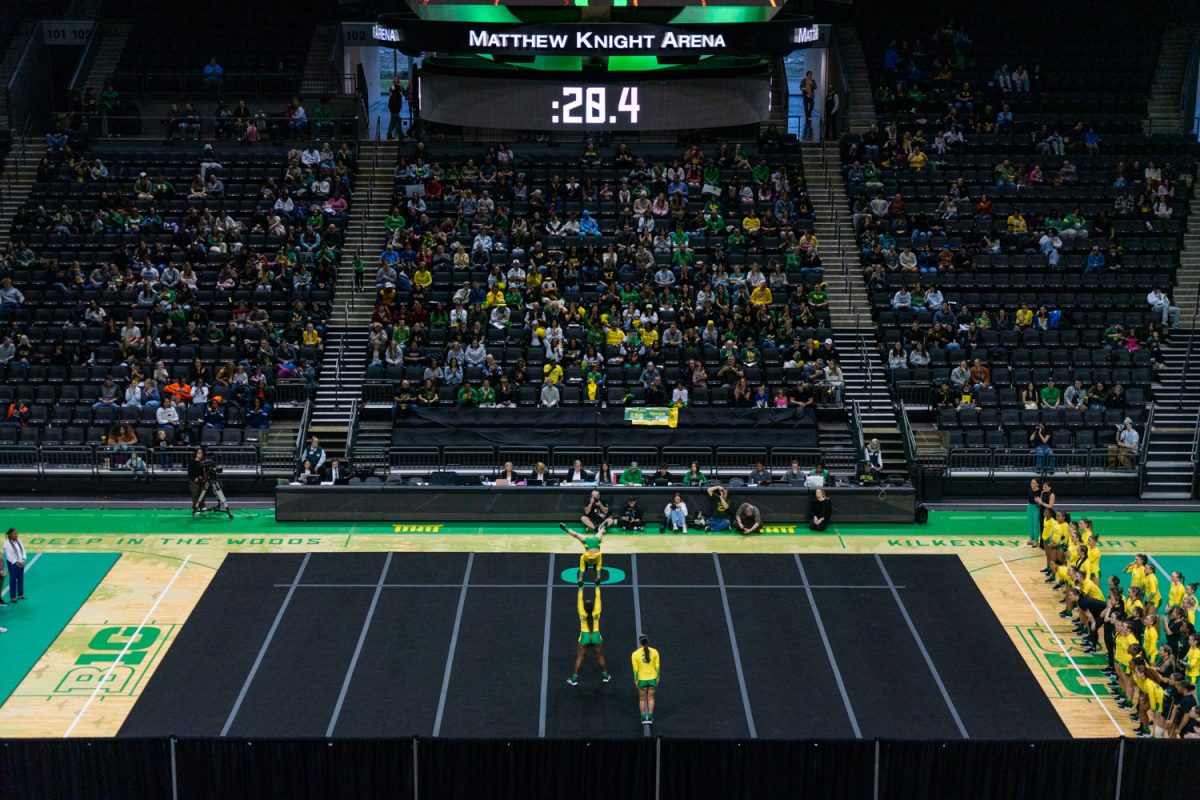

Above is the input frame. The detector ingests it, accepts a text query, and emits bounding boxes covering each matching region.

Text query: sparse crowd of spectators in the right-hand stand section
[844,23,1192,471]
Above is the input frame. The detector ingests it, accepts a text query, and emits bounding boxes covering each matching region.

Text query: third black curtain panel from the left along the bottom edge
[416,739,657,800]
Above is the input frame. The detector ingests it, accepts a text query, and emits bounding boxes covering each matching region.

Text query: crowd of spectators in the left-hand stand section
[0,131,354,446]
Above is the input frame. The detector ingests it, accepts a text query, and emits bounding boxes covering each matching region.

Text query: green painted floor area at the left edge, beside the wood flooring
[0,553,121,704]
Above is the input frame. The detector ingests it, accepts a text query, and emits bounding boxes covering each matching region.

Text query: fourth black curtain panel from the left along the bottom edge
[661,739,875,800]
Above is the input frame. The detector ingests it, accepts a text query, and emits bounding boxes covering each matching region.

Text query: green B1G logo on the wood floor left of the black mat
[54,625,175,696]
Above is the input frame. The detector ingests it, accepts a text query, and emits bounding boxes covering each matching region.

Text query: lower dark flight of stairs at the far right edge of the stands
[1141,329,1200,500]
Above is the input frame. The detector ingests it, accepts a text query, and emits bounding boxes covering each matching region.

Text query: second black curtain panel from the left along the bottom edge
[174,739,413,800]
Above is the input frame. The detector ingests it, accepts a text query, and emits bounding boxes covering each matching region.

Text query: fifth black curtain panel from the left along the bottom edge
[880,739,1120,800]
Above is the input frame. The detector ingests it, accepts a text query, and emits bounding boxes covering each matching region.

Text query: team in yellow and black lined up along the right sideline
[1028,479,1200,739]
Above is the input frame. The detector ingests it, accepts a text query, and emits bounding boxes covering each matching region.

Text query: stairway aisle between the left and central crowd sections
[308,140,395,457]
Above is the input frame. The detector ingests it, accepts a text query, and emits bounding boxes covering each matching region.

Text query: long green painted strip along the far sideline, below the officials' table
[7,506,1200,549]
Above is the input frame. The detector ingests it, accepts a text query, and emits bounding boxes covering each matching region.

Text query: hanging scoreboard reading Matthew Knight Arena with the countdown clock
[374,0,828,132]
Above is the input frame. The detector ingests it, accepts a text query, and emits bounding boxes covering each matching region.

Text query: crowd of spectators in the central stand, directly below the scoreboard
[369,143,842,414]
